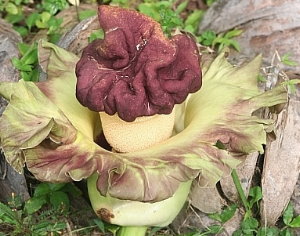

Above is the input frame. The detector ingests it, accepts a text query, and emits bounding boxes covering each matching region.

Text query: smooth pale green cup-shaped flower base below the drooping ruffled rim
[88,174,191,227]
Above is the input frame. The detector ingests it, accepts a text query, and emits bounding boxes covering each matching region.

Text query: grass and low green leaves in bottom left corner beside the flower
[0,183,108,236]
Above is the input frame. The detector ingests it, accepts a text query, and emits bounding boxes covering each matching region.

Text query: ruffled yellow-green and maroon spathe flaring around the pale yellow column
[0,5,287,230]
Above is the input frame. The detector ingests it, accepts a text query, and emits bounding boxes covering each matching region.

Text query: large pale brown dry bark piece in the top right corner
[199,0,300,74]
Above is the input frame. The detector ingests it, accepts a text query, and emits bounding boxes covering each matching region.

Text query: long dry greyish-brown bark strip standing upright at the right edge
[261,90,300,225]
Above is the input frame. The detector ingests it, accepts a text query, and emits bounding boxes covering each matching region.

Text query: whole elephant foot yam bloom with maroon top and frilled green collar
[0,6,287,236]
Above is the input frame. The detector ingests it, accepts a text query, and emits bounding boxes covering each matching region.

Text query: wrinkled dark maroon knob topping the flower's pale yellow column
[76,6,201,121]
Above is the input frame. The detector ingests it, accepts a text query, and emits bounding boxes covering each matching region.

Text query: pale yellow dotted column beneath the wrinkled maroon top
[99,109,175,152]
